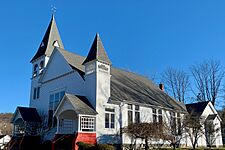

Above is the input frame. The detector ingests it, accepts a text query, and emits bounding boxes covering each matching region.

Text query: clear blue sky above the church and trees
[0,0,225,112]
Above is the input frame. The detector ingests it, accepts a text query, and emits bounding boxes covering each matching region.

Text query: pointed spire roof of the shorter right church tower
[83,33,111,65]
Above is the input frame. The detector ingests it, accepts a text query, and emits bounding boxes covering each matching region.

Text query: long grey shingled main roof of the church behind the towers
[56,49,186,111]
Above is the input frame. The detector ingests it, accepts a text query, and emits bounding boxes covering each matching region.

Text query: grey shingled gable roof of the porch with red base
[64,93,97,115]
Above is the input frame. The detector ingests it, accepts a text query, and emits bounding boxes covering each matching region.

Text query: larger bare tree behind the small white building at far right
[191,60,225,105]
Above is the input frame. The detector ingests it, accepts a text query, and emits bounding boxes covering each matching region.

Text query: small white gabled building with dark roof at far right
[186,101,223,147]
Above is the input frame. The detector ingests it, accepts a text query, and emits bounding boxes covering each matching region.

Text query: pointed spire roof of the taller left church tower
[31,15,64,62]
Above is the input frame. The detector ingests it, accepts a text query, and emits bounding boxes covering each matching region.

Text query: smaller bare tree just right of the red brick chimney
[161,67,190,102]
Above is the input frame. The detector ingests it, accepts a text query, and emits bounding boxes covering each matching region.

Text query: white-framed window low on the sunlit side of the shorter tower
[105,108,115,128]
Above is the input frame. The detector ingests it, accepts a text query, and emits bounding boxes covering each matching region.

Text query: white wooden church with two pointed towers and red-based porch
[9,16,222,149]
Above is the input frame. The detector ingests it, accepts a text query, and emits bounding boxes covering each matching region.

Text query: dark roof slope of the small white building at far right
[186,101,209,117]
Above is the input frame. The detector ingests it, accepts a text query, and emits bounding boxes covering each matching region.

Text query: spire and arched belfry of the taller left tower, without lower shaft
[30,15,64,78]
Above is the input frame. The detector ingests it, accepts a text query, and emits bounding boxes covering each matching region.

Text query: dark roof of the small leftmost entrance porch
[17,107,41,122]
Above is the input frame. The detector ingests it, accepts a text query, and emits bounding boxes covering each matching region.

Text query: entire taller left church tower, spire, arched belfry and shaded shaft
[30,15,64,106]
